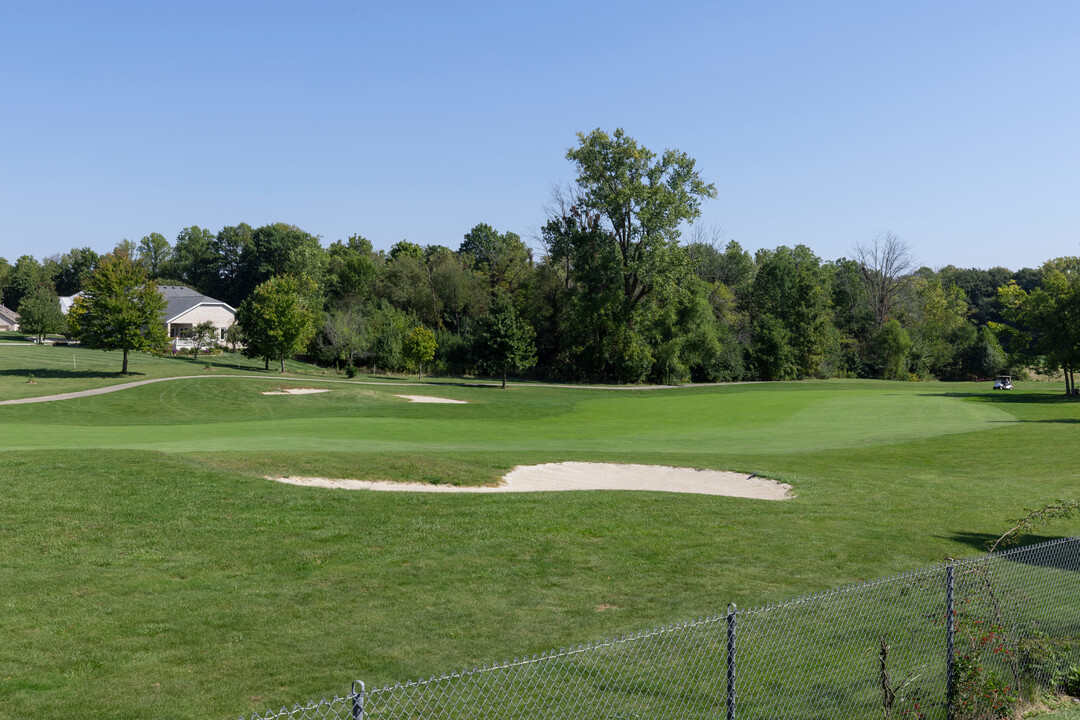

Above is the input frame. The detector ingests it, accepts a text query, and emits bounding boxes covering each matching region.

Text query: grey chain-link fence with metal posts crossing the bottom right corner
[241,538,1080,720]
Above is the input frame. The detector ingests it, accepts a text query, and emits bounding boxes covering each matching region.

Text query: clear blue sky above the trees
[0,0,1080,269]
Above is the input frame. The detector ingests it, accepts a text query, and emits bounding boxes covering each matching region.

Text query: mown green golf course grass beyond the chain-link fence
[0,347,1080,718]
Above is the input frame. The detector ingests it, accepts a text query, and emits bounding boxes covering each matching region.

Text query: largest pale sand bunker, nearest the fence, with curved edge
[271,462,792,500]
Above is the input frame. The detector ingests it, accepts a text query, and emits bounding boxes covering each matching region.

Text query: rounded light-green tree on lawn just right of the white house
[237,275,315,372]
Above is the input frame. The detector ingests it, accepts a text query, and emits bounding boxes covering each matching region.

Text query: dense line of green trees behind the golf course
[0,130,1080,389]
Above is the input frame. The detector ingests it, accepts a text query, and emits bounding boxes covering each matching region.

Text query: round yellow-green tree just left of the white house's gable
[69,253,168,375]
